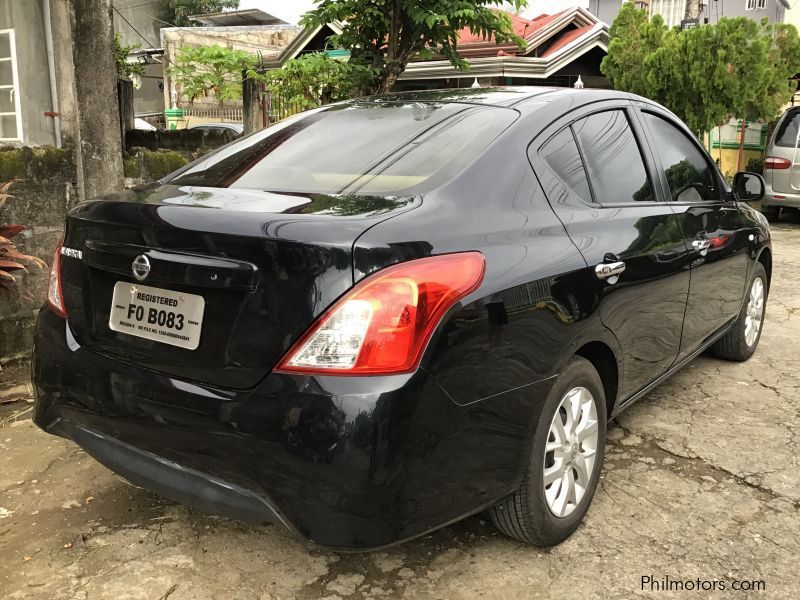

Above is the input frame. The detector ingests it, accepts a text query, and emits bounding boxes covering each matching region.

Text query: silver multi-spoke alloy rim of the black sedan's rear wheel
[543,387,598,517]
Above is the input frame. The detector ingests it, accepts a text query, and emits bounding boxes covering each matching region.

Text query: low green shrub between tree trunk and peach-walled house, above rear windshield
[255,52,374,109]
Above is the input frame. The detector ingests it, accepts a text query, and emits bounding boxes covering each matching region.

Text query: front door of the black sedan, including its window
[639,108,749,357]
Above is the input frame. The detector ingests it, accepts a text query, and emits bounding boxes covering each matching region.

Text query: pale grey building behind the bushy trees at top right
[589,0,792,27]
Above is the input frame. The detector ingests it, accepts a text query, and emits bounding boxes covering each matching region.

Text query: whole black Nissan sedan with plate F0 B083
[33,88,772,549]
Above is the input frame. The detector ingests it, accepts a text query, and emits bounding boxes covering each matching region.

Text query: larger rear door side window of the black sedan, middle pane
[573,110,655,204]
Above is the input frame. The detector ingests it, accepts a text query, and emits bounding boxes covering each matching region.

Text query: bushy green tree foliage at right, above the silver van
[600,2,800,135]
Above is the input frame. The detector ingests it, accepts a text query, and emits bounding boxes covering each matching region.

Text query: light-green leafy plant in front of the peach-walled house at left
[169,44,255,104]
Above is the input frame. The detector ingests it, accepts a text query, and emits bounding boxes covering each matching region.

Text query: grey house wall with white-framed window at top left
[0,0,61,146]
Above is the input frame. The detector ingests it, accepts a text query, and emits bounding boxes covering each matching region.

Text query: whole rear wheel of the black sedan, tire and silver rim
[490,357,606,546]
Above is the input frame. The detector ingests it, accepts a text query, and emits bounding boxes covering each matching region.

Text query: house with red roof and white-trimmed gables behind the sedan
[397,7,608,90]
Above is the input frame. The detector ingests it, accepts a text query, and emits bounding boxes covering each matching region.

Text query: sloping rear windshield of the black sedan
[165,102,517,195]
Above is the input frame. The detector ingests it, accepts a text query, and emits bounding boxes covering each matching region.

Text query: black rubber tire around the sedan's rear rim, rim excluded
[489,356,606,547]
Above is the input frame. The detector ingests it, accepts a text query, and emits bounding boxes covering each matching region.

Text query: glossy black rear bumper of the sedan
[33,310,551,550]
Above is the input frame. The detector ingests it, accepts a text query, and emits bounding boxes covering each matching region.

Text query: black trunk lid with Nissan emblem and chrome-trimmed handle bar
[61,185,416,389]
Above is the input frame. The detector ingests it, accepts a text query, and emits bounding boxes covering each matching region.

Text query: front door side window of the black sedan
[644,113,719,202]
